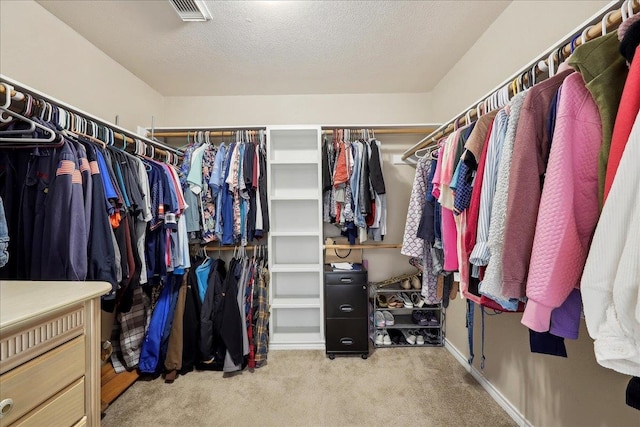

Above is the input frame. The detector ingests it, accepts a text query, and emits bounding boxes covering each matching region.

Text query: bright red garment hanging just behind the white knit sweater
[604,46,640,200]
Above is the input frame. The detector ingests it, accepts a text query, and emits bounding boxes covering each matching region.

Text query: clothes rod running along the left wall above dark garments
[0,74,183,157]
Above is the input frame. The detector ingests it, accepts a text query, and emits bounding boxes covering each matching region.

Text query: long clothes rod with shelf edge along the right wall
[402,0,640,160]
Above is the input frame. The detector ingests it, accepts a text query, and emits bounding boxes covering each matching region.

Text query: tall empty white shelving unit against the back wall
[267,126,324,349]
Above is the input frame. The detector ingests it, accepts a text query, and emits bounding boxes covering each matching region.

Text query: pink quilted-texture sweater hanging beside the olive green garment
[522,73,602,332]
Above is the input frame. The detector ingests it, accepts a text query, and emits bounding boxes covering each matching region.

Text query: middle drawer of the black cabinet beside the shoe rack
[324,284,369,318]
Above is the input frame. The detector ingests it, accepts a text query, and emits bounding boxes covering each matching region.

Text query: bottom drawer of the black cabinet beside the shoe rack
[325,317,369,354]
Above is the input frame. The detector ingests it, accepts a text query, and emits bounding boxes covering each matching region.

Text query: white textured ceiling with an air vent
[39,0,510,96]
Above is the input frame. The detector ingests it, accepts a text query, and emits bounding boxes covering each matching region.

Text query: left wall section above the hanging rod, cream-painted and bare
[0,0,163,130]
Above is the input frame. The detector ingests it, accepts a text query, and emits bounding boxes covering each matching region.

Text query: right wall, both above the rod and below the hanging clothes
[432,1,640,427]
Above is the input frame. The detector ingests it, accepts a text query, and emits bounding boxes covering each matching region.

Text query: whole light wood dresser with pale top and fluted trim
[0,281,111,427]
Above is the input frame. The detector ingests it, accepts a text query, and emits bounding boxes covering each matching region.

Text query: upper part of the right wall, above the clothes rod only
[431,0,609,122]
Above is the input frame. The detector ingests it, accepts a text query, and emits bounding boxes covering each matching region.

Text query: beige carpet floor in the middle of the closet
[102,348,516,427]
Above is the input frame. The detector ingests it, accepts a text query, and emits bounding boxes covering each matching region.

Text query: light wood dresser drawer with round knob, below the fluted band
[0,336,85,426]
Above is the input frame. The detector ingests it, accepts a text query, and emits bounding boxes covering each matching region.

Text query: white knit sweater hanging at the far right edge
[581,114,640,376]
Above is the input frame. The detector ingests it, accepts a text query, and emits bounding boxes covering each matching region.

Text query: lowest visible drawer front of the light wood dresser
[12,378,85,427]
